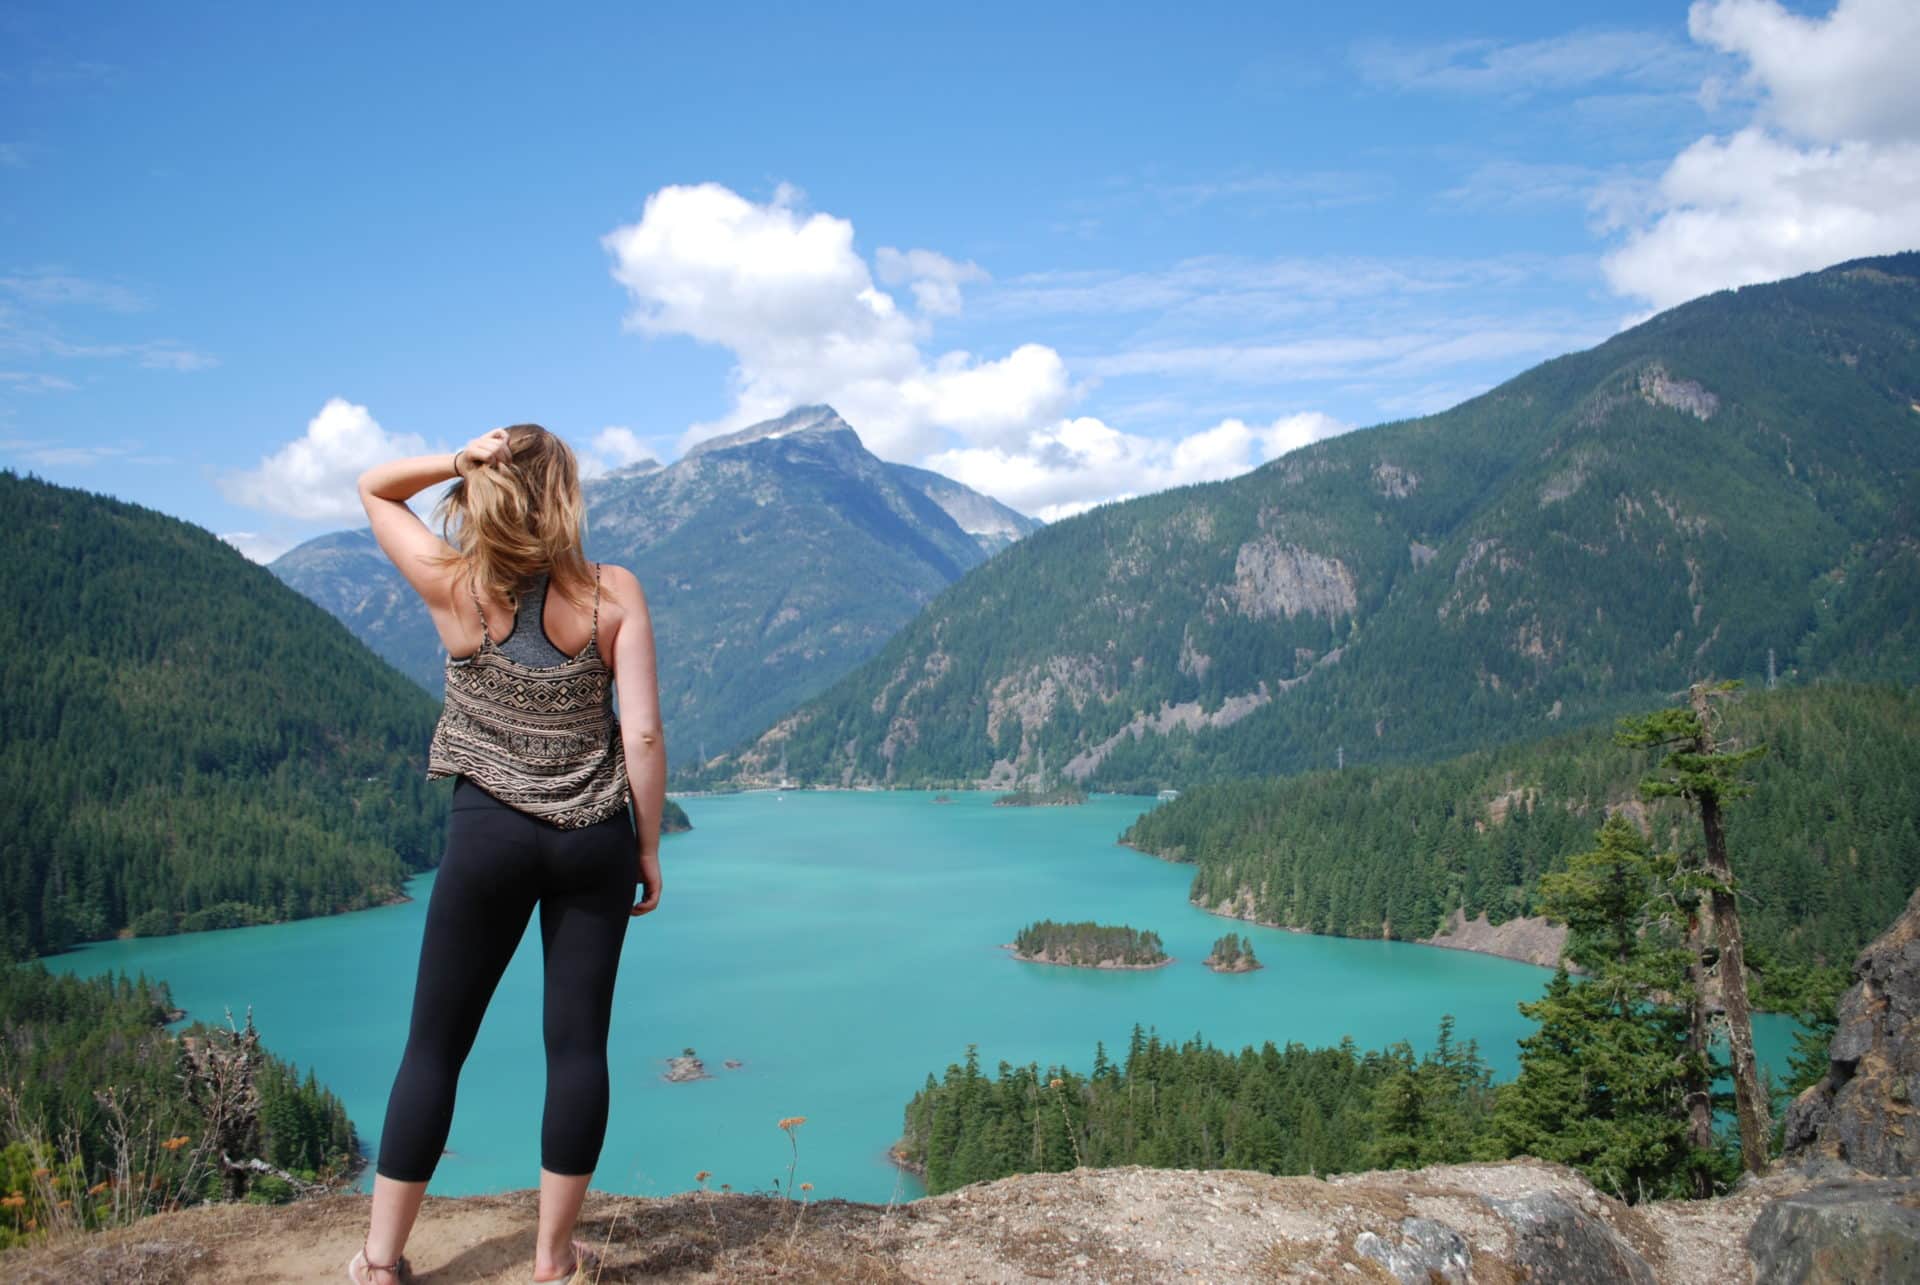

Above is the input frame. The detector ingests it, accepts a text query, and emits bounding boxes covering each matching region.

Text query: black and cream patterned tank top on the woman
[426,563,632,830]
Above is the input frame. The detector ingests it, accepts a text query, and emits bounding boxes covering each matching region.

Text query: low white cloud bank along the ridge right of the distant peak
[927,411,1350,522]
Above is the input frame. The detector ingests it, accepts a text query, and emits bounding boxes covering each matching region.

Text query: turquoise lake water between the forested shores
[48,791,1793,1200]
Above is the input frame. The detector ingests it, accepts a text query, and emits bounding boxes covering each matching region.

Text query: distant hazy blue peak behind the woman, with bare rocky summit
[273,405,1039,763]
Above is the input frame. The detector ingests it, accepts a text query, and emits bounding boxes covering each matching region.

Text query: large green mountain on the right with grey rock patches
[728,254,1920,788]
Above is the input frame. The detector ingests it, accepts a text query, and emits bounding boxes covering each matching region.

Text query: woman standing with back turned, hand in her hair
[348,424,666,1285]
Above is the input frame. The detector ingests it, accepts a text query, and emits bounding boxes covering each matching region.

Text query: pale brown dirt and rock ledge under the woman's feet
[0,1160,1812,1285]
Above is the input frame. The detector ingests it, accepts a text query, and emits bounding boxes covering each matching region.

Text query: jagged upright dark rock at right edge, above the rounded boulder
[1786,889,1920,1177]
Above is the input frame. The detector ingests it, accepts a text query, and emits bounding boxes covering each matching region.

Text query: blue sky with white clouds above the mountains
[0,0,1920,557]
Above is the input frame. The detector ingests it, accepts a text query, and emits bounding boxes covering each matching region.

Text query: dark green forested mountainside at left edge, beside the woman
[0,471,447,957]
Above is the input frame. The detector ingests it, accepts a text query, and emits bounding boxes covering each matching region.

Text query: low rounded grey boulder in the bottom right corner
[1747,1177,1920,1285]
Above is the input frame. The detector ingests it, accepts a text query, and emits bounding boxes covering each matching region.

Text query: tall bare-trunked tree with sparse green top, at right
[1615,680,1772,1174]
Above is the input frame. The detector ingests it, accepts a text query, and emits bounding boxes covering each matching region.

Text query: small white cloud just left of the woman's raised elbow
[219,398,426,521]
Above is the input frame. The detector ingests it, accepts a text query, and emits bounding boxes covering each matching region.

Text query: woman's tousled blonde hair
[432,424,593,611]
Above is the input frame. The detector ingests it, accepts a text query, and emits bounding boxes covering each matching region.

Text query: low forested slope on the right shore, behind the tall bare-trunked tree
[1123,684,1920,1006]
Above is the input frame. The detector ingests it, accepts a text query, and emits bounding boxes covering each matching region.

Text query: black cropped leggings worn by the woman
[376,776,639,1183]
